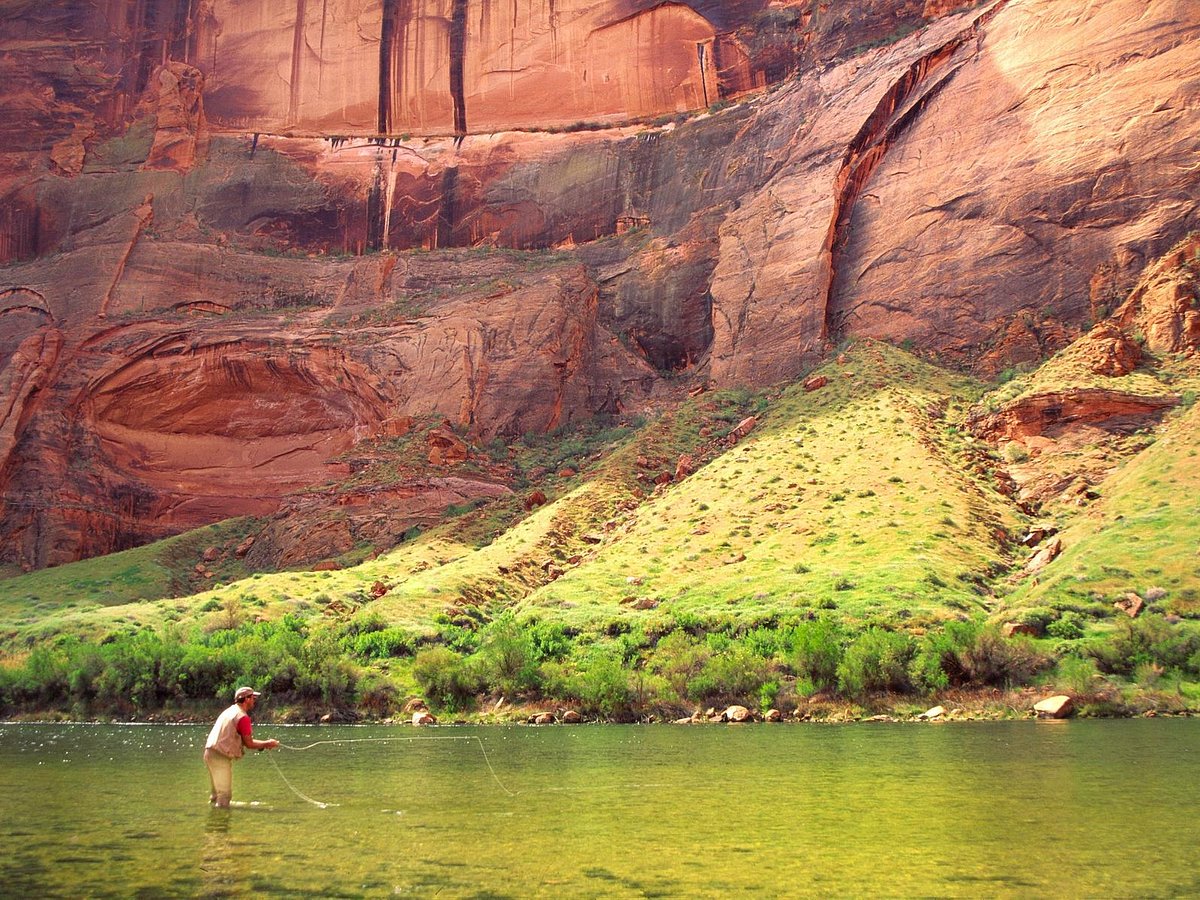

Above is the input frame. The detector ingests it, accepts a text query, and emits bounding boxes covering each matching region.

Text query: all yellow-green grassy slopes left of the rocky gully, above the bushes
[0,343,1020,636]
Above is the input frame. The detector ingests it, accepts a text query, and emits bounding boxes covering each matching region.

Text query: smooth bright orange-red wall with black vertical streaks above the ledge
[200,0,719,134]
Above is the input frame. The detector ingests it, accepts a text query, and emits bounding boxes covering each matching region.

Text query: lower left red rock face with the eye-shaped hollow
[0,248,640,566]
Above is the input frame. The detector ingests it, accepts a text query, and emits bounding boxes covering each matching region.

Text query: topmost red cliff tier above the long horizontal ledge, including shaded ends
[0,0,952,142]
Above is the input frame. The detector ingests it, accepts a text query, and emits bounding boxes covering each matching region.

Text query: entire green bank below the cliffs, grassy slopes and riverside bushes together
[0,342,1200,718]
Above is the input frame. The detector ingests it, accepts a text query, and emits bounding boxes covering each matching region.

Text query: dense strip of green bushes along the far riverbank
[0,613,1200,720]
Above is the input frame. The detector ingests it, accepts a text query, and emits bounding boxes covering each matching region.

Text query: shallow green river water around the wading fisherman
[0,719,1200,898]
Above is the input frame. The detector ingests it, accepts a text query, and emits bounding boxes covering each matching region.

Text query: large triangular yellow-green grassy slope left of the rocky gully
[524,343,1016,628]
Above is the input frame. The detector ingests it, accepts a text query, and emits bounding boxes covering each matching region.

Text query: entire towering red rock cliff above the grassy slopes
[0,0,1200,566]
